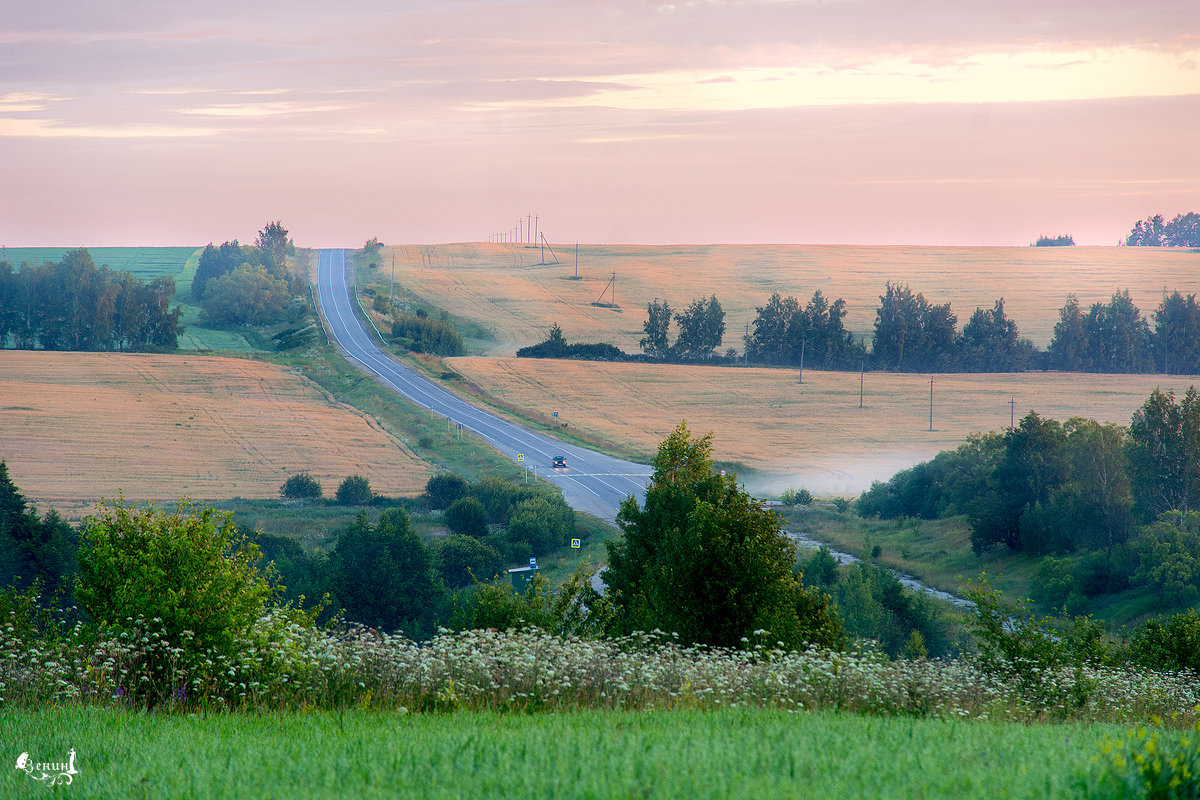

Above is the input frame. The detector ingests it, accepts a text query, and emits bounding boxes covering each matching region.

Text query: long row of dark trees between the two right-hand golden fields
[517,281,1200,374]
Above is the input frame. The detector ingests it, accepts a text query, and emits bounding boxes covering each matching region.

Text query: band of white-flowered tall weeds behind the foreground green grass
[0,612,1200,722]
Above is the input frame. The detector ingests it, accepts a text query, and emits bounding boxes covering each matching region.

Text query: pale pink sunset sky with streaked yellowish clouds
[0,0,1200,247]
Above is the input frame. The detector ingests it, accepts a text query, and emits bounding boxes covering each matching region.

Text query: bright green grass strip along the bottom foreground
[0,708,1120,800]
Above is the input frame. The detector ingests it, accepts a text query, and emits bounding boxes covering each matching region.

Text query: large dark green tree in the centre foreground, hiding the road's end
[605,425,845,648]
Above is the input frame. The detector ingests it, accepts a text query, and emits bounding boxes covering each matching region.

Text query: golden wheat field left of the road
[0,350,428,511]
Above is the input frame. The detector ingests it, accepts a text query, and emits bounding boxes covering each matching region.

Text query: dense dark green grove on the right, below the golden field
[857,387,1200,606]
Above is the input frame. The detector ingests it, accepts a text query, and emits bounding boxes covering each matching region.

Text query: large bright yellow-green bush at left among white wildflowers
[76,503,277,704]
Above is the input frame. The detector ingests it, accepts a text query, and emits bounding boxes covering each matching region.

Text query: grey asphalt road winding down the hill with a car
[317,249,650,522]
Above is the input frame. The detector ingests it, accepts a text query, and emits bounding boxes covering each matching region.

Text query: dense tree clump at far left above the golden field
[0,248,184,350]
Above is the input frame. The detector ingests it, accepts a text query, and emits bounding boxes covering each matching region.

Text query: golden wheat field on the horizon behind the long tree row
[376,243,1200,355]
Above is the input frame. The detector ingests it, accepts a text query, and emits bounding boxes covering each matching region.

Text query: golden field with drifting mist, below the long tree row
[446,357,1200,494]
